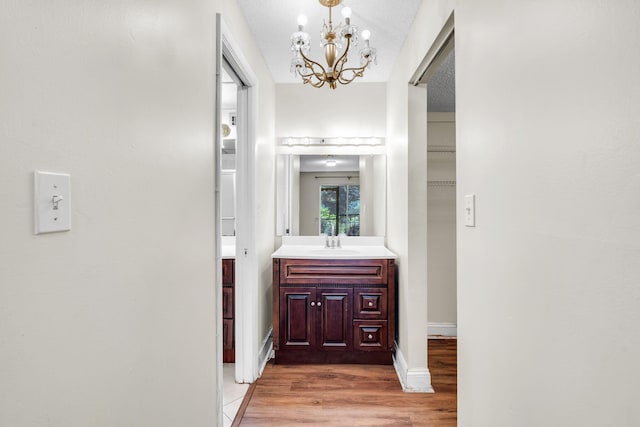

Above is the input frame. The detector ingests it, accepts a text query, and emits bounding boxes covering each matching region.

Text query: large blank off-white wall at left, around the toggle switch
[0,0,216,427]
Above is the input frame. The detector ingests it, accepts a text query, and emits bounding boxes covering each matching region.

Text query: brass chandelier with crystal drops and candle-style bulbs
[291,0,377,89]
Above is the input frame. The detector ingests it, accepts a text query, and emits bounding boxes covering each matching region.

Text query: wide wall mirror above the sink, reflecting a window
[276,154,387,236]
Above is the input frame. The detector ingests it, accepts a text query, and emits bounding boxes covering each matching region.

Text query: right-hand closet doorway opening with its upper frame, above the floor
[410,13,459,384]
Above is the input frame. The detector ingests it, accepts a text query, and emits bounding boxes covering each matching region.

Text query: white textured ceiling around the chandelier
[238,0,422,83]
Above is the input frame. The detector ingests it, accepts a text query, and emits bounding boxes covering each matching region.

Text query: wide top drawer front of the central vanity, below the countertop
[280,259,388,285]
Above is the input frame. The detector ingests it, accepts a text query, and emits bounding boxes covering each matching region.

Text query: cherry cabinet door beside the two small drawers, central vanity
[316,289,353,351]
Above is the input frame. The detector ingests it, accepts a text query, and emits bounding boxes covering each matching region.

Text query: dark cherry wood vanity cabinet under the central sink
[273,259,395,364]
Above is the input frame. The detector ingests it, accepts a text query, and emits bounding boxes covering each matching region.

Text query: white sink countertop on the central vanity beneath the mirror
[271,236,398,259]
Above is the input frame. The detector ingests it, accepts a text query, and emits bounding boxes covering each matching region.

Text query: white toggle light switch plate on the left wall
[33,171,71,234]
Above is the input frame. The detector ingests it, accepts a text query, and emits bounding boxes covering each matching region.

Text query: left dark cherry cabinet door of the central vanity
[280,287,317,350]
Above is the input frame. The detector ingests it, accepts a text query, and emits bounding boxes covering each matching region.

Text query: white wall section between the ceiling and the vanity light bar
[275,83,387,138]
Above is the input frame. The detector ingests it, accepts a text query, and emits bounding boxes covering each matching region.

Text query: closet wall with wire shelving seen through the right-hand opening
[427,113,457,328]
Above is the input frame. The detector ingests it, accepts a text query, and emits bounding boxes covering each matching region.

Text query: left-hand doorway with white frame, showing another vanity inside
[215,14,258,425]
